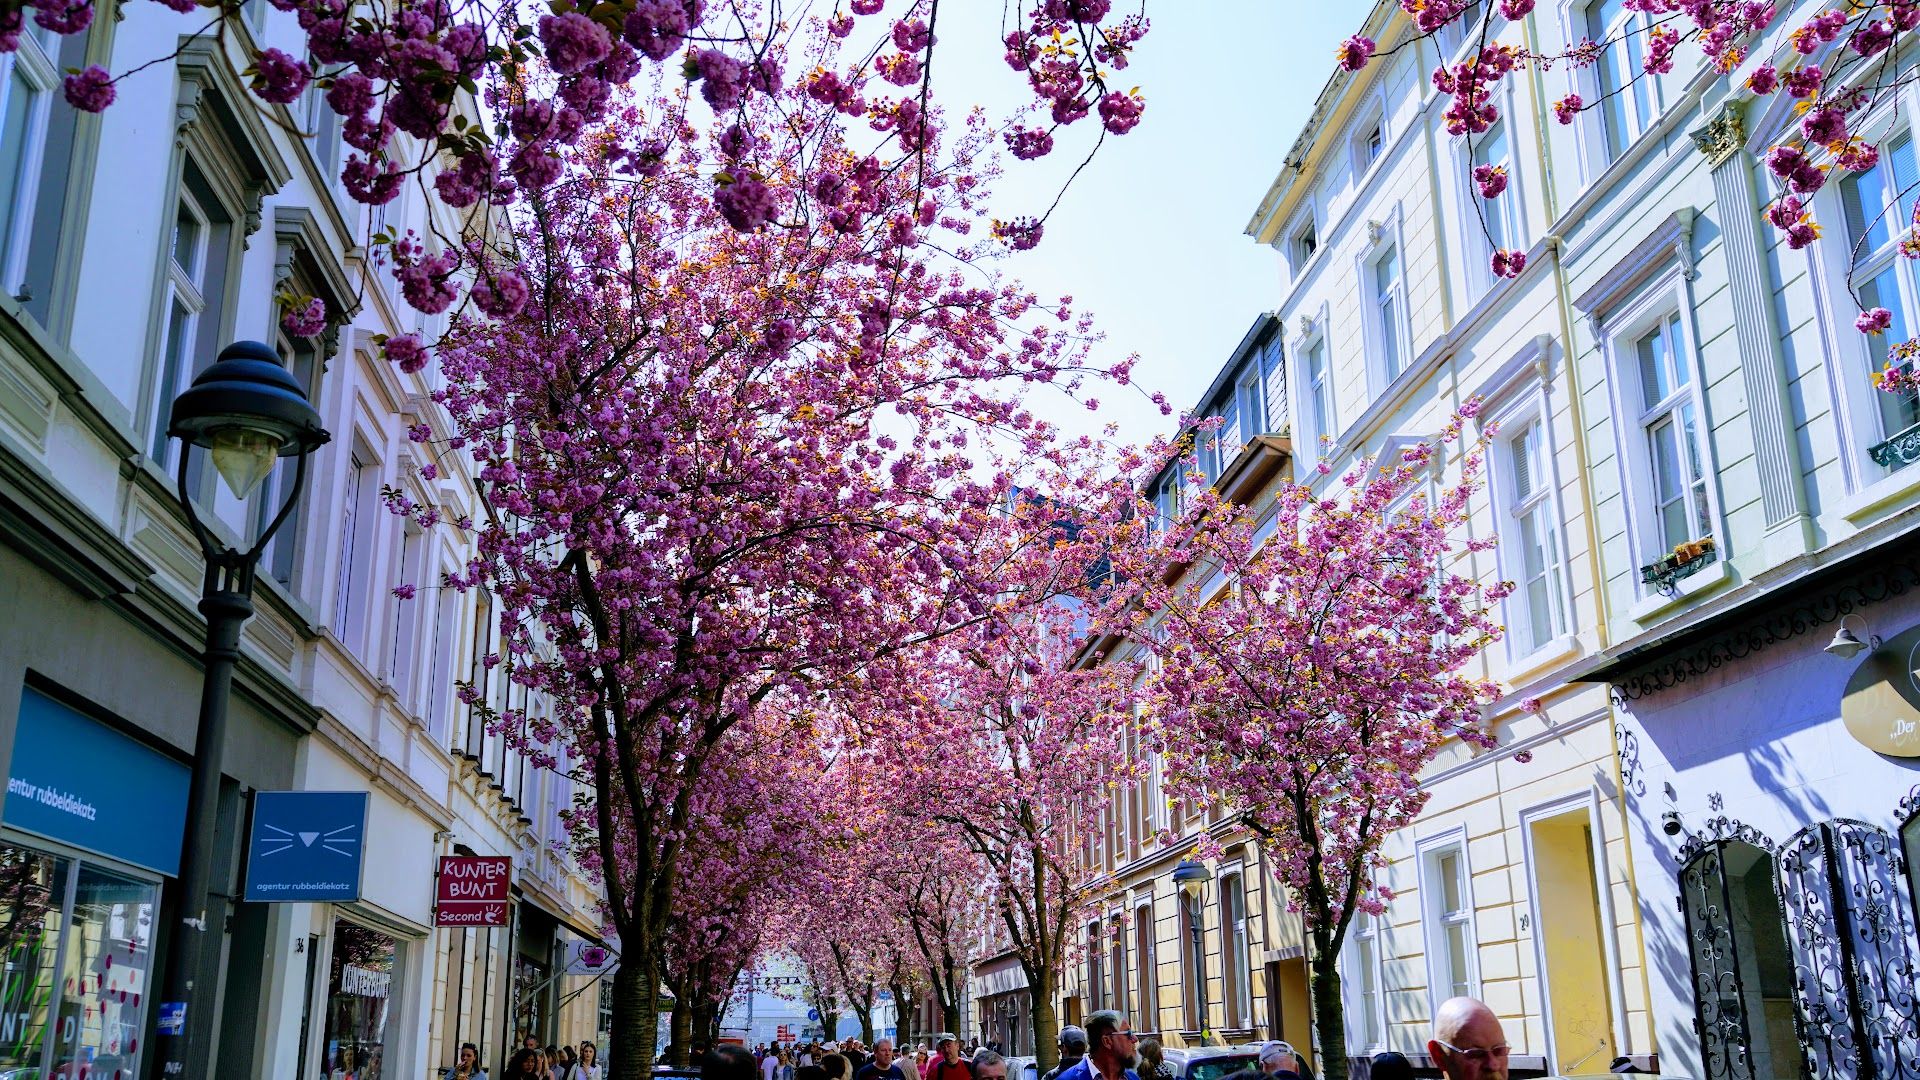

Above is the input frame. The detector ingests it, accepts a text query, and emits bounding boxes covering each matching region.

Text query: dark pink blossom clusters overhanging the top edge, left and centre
[22,0,1146,267]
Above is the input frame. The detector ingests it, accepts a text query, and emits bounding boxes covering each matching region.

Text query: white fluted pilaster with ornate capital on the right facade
[1690,100,1811,549]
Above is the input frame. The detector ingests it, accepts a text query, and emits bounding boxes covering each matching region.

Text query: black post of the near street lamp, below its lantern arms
[159,572,253,1076]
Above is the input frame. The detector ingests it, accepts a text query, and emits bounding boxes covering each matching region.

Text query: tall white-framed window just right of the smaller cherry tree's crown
[1501,417,1567,655]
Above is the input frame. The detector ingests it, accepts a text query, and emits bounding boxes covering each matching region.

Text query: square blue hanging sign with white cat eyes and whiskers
[244,792,367,903]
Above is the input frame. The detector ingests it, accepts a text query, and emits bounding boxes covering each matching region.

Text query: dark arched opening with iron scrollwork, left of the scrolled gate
[1680,830,1801,1080]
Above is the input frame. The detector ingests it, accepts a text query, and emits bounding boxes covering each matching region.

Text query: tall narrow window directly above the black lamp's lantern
[152,160,232,463]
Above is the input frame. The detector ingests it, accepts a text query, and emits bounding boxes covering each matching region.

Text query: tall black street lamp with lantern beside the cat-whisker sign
[157,342,332,1078]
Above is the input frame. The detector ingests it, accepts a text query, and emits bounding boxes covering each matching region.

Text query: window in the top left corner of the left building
[0,21,88,327]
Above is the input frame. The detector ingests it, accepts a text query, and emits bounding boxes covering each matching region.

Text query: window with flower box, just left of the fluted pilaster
[1634,313,1713,552]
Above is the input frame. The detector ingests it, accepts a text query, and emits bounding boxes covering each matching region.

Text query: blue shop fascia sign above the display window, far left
[0,688,188,876]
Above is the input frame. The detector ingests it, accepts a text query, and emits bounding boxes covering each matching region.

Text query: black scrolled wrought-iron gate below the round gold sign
[1780,819,1920,1080]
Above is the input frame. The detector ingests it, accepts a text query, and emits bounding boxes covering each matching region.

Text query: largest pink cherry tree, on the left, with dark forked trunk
[403,58,1125,1078]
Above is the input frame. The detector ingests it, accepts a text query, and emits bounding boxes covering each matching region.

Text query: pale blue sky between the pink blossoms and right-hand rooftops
[933,0,1371,442]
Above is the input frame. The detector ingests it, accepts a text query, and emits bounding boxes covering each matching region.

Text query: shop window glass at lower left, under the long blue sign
[0,844,159,1080]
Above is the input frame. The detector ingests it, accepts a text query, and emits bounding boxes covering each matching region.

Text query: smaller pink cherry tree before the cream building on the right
[1114,417,1511,1080]
